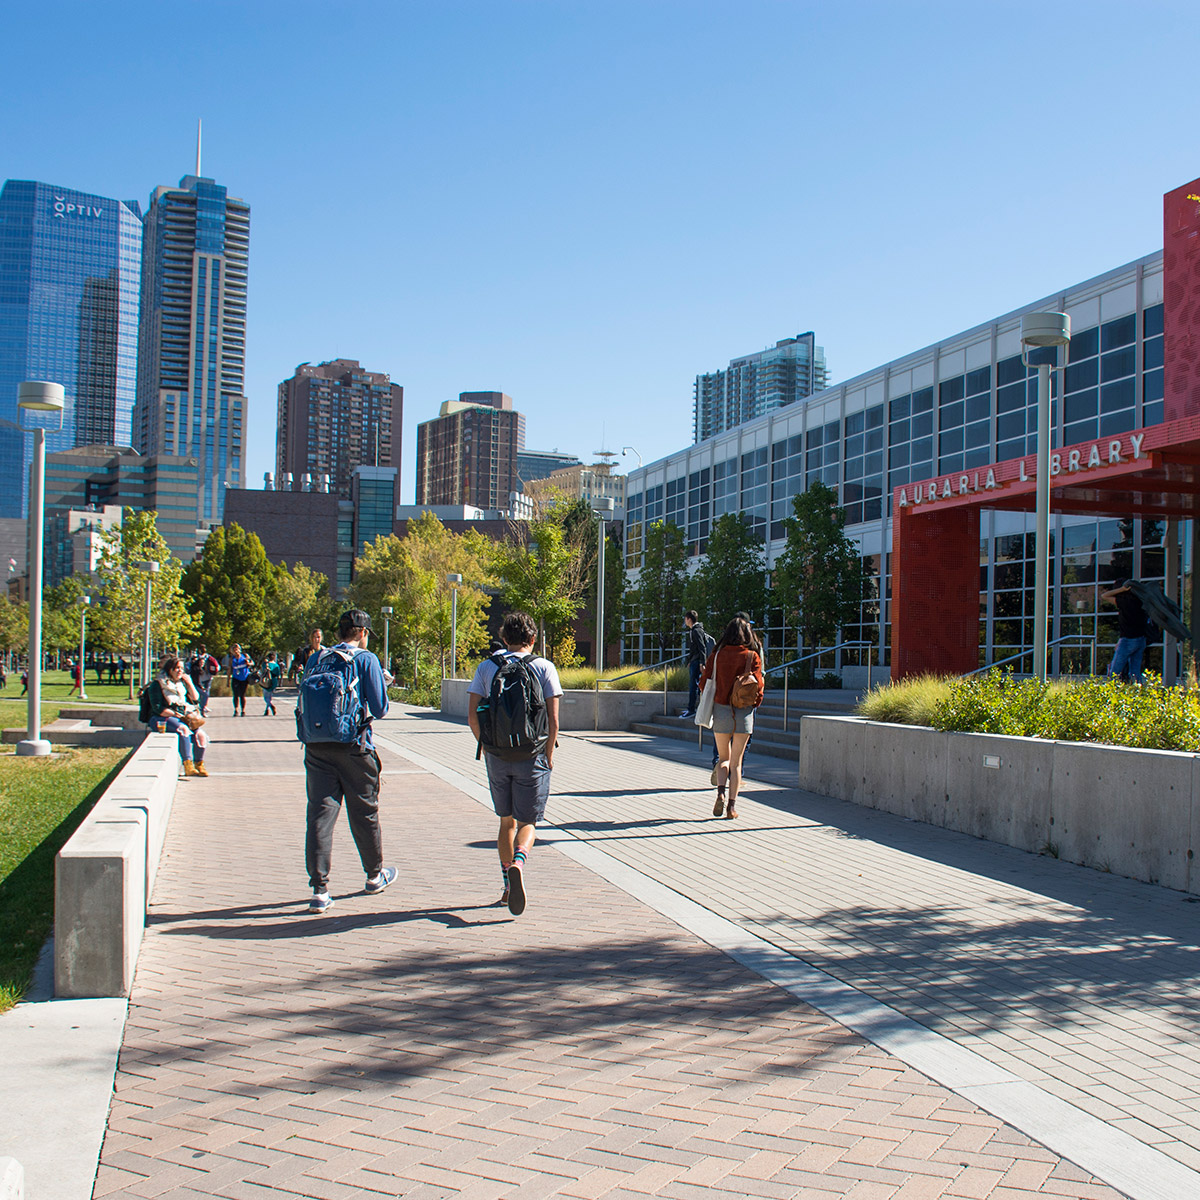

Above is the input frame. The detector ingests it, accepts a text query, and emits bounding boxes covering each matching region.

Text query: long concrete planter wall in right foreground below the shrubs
[799,716,1200,892]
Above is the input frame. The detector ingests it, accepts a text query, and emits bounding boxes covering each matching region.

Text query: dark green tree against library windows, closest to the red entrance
[773,484,870,649]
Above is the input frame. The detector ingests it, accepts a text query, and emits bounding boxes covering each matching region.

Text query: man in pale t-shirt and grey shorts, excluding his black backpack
[467,612,563,917]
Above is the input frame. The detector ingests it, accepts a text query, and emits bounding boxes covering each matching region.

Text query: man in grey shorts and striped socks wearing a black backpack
[467,612,563,917]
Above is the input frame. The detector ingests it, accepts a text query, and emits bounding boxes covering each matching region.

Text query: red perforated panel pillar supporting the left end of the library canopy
[892,505,979,679]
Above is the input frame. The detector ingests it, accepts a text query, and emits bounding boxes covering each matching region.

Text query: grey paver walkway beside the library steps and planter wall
[407,716,1200,1180]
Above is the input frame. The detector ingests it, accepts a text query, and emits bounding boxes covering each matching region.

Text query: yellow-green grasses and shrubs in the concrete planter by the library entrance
[859,671,1200,751]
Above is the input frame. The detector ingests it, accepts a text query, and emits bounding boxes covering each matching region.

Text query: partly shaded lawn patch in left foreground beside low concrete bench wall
[0,748,132,1012]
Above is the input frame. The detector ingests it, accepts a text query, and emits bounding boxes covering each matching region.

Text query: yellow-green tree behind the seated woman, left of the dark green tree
[91,509,198,697]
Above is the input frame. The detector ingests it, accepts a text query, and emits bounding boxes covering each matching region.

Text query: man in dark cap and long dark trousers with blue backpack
[296,608,396,912]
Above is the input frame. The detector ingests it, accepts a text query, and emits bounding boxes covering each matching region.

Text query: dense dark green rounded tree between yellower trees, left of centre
[184,522,276,654]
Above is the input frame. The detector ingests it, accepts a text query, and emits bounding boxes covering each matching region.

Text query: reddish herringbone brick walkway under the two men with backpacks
[95,708,1117,1200]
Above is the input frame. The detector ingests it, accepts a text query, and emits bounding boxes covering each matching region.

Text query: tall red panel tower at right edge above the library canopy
[1163,179,1200,421]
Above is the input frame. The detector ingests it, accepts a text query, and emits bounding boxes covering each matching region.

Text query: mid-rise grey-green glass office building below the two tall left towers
[43,445,204,587]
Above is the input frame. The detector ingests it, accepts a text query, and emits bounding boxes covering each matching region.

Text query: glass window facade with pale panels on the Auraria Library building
[625,253,1171,671]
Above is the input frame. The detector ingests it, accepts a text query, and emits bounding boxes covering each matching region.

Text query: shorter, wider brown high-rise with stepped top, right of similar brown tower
[416,391,524,509]
